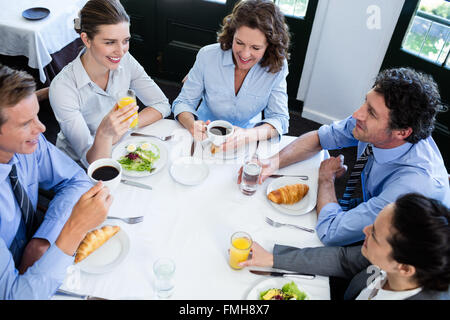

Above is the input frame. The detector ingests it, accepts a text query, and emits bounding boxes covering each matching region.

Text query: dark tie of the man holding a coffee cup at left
[9,164,37,240]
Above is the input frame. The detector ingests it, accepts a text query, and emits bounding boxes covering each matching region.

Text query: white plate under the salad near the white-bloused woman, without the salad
[111,137,169,178]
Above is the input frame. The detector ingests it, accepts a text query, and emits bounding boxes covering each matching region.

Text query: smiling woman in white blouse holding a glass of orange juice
[49,0,171,167]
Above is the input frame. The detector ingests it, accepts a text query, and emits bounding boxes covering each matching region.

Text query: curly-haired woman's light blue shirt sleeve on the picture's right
[257,60,289,139]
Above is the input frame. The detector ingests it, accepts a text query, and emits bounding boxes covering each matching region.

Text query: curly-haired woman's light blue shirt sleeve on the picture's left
[172,49,205,119]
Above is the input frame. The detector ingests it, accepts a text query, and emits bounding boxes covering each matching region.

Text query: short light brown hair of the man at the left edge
[0,64,36,128]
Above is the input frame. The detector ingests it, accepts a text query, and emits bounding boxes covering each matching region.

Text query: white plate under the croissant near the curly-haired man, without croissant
[266,169,318,216]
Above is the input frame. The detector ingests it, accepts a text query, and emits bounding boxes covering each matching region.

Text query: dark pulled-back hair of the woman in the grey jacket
[388,193,450,291]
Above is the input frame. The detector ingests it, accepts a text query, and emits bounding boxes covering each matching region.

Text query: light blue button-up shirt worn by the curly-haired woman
[172,43,289,136]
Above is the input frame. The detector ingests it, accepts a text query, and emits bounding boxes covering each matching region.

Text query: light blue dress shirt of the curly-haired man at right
[316,117,450,246]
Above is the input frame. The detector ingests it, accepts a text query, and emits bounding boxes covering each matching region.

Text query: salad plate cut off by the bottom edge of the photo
[247,278,313,300]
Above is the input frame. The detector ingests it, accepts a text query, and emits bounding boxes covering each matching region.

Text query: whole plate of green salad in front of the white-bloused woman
[111,137,169,178]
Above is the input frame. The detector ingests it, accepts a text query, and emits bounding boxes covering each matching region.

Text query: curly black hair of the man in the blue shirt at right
[373,68,443,143]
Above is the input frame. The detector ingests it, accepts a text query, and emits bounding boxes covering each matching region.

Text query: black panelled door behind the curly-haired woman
[121,0,318,106]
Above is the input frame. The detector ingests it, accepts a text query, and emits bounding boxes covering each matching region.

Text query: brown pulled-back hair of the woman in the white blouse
[74,0,130,39]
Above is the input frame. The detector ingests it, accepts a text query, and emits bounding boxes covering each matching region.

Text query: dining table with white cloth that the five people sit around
[53,119,330,300]
